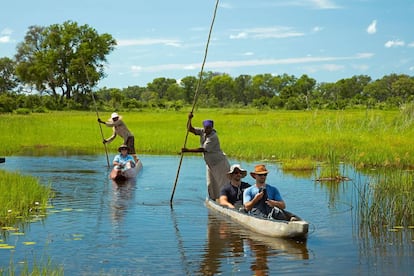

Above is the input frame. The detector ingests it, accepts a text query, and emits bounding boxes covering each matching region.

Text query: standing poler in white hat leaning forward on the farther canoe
[98,112,138,162]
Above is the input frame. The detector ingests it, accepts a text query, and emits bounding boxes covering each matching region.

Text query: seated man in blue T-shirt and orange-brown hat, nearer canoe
[243,165,297,220]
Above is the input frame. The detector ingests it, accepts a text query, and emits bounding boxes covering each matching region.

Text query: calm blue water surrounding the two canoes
[0,156,414,275]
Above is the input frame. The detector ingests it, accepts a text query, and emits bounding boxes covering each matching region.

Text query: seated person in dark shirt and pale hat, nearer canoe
[219,164,250,209]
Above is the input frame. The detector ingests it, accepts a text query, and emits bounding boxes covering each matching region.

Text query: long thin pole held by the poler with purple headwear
[170,0,219,206]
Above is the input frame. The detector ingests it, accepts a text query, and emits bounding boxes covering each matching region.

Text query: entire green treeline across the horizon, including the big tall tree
[0,21,414,113]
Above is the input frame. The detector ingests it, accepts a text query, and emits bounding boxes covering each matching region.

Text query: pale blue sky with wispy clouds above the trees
[0,0,414,89]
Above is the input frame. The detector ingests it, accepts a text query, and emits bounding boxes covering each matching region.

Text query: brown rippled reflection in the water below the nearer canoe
[198,212,309,275]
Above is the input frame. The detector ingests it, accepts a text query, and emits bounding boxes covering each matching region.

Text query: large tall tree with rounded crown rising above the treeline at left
[16,21,116,106]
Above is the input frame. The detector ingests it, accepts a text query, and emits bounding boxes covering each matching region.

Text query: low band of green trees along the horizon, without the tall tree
[0,72,414,113]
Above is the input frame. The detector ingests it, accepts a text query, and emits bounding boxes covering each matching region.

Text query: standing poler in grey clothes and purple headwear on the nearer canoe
[181,113,230,200]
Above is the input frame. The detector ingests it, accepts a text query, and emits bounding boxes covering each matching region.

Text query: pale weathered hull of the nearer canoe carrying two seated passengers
[206,199,309,238]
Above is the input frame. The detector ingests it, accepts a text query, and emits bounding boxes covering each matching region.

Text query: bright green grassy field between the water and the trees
[0,109,414,168]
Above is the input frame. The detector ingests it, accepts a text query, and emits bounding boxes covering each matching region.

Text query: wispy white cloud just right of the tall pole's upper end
[230,26,304,39]
